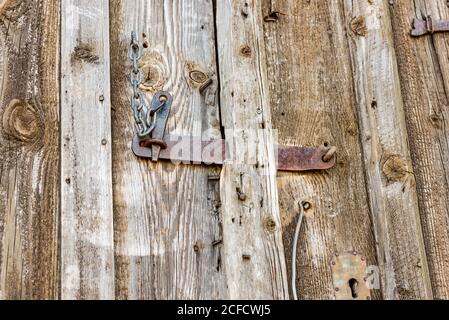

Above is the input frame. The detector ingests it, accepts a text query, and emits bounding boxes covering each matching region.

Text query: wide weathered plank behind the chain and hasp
[111,0,227,299]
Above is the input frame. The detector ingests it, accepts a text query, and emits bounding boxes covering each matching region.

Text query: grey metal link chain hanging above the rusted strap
[128,31,166,138]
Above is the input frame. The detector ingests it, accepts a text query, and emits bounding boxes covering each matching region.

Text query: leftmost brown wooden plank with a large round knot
[0,0,59,299]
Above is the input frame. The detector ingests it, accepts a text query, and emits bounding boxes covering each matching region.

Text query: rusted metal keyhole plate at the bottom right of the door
[331,252,371,300]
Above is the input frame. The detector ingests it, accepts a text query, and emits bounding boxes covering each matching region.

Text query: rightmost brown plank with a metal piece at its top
[391,0,449,299]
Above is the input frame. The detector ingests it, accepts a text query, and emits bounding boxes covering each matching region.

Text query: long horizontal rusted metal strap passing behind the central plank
[132,135,336,172]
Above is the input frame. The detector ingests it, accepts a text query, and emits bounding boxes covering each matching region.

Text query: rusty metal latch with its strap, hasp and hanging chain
[128,32,336,171]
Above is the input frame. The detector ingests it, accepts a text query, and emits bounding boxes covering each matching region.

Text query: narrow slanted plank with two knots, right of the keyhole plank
[345,0,432,300]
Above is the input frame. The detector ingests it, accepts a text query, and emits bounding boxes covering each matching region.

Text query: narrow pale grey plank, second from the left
[61,0,114,299]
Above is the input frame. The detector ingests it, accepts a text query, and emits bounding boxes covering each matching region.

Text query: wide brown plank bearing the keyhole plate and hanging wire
[263,0,382,300]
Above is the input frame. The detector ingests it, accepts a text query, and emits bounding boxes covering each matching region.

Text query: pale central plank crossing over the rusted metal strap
[216,0,288,299]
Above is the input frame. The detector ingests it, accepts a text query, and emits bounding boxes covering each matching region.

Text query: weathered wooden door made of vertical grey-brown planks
[0,0,449,299]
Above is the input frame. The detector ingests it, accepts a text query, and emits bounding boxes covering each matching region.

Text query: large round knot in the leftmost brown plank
[2,99,43,143]
